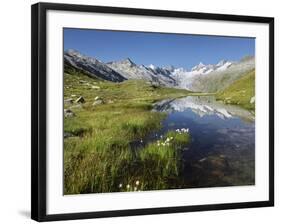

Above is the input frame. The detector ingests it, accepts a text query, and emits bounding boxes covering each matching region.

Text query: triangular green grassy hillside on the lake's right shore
[216,70,255,110]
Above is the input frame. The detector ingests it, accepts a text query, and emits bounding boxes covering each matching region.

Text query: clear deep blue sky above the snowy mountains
[64,28,255,69]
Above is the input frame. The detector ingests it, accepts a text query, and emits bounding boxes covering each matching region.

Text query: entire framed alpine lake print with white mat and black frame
[32,3,274,221]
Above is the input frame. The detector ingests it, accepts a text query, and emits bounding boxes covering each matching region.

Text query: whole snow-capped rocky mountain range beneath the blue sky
[64,50,255,92]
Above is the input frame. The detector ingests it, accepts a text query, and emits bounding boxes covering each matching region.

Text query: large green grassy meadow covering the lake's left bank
[64,68,190,194]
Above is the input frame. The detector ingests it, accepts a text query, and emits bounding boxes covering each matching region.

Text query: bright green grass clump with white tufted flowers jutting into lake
[137,131,190,190]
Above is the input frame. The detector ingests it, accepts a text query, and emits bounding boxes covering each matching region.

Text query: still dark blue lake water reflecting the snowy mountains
[149,96,255,188]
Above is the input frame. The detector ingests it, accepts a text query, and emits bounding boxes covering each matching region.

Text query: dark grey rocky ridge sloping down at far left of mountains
[64,50,126,82]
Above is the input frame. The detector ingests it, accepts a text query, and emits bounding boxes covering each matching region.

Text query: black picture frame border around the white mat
[31,3,274,221]
